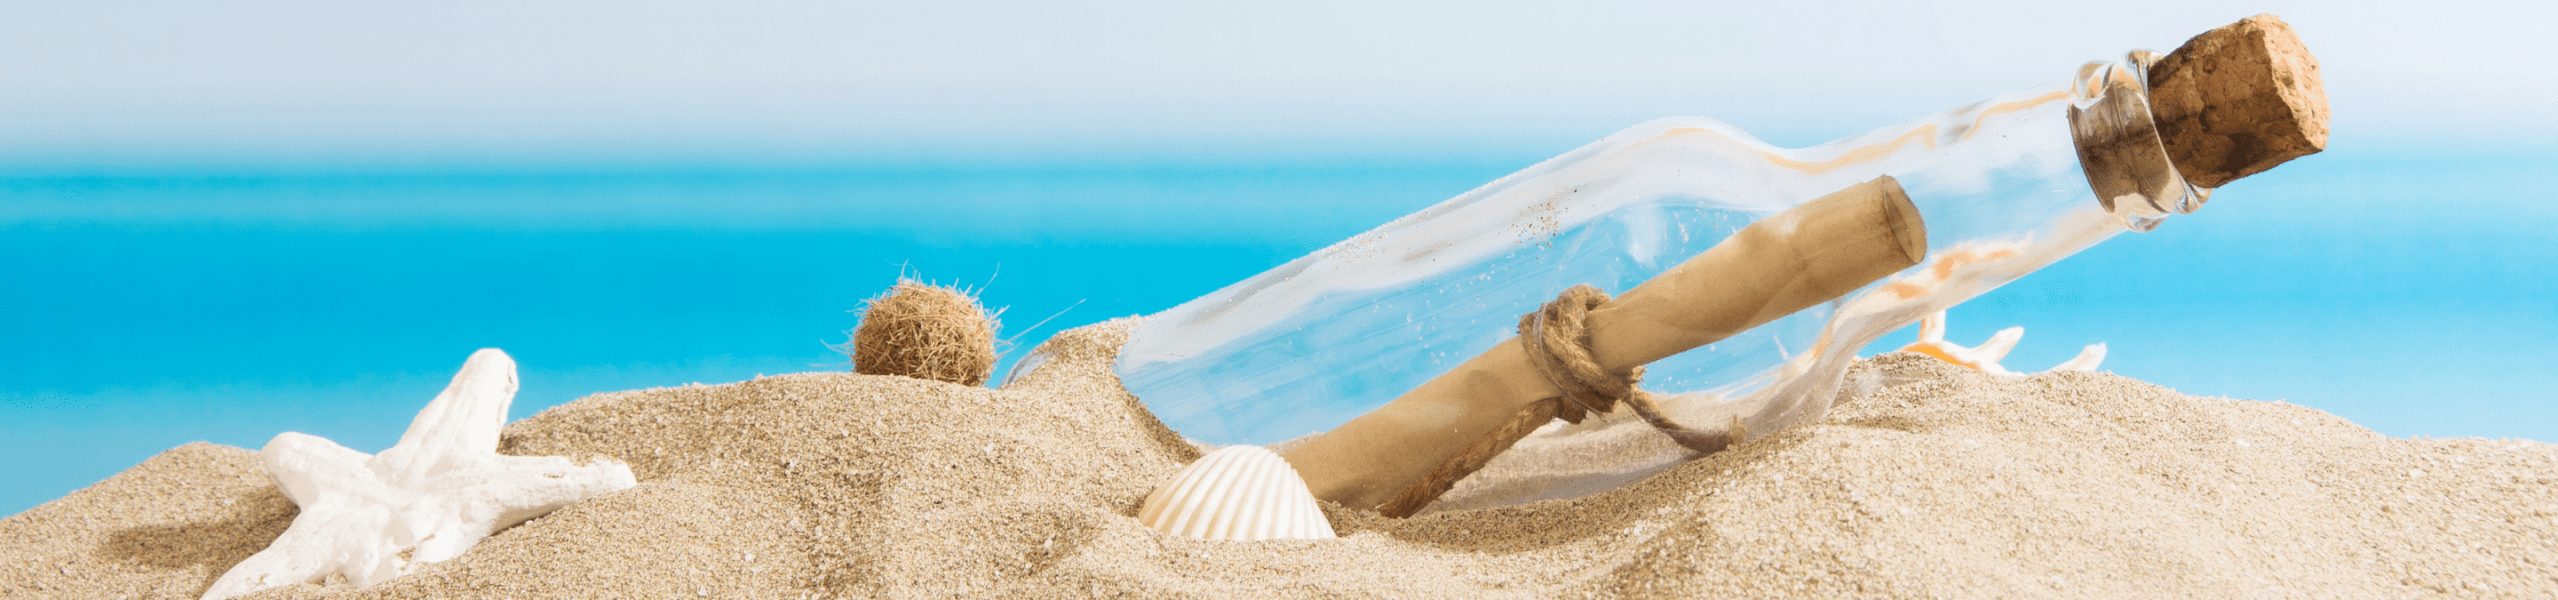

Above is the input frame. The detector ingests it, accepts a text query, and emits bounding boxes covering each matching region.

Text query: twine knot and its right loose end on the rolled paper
[1519,286,1750,454]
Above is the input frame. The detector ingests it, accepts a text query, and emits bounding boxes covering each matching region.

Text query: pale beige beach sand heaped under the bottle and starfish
[0,322,2558,597]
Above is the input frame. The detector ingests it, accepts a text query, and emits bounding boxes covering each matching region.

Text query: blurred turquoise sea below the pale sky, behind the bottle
[0,148,2558,513]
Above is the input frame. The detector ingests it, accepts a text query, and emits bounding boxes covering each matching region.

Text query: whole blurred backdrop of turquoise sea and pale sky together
[0,3,2558,516]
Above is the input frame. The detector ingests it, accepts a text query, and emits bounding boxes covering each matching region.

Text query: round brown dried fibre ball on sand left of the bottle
[847,281,995,386]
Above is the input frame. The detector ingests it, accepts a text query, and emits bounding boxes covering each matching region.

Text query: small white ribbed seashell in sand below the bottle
[1136,447,1335,539]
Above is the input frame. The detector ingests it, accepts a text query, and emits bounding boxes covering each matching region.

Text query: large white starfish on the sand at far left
[205,347,637,600]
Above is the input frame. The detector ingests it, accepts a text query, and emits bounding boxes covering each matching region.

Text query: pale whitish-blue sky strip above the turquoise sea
[0,0,2558,171]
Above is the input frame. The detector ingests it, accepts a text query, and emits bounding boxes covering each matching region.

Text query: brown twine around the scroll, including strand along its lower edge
[1379,286,1750,518]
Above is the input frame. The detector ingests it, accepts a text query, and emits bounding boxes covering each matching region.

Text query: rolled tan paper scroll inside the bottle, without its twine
[1287,176,1926,513]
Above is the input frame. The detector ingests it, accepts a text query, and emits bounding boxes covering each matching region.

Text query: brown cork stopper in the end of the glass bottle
[2149,15,2328,189]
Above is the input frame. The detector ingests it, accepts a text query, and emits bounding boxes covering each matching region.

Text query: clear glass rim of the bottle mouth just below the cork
[2069,51,2213,232]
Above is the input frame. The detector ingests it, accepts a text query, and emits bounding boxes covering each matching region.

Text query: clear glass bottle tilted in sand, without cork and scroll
[1089,15,2325,503]
